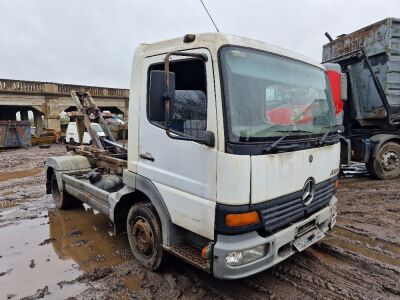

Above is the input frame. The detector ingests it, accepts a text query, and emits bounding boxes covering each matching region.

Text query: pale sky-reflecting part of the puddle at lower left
[0,218,85,299]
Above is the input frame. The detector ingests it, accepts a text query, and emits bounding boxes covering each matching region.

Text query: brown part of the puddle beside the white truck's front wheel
[49,206,132,271]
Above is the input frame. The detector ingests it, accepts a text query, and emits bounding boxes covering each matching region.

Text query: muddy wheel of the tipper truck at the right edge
[367,142,400,180]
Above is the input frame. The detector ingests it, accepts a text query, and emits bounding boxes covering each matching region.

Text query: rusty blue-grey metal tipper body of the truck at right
[322,18,400,123]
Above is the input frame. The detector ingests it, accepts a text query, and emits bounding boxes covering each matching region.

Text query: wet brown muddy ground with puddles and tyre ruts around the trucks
[0,145,400,300]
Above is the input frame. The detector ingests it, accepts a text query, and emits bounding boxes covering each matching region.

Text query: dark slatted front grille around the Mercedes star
[260,178,336,233]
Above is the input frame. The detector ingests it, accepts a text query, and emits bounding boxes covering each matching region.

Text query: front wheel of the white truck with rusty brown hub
[126,202,164,271]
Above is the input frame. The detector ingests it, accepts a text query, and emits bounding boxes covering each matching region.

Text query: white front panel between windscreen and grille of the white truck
[251,144,340,204]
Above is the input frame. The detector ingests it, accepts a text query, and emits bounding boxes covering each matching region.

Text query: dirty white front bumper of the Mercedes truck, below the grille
[212,196,337,279]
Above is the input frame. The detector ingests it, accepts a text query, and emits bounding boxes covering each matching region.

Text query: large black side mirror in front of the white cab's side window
[148,70,175,122]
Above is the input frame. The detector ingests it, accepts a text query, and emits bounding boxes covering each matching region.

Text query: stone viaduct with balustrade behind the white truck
[0,79,129,131]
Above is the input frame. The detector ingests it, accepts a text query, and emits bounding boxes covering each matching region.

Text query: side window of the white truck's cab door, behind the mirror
[148,59,207,137]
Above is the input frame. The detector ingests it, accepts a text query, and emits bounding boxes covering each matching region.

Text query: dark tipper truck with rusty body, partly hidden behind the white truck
[322,18,400,179]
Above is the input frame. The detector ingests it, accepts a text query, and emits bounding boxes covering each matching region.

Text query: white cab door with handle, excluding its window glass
[137,49,217,238]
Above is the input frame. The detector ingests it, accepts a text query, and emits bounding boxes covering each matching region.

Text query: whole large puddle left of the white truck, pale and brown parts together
[0,206,134,299]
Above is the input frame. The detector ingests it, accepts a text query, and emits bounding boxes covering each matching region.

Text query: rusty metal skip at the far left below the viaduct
[0,121,31,149]
